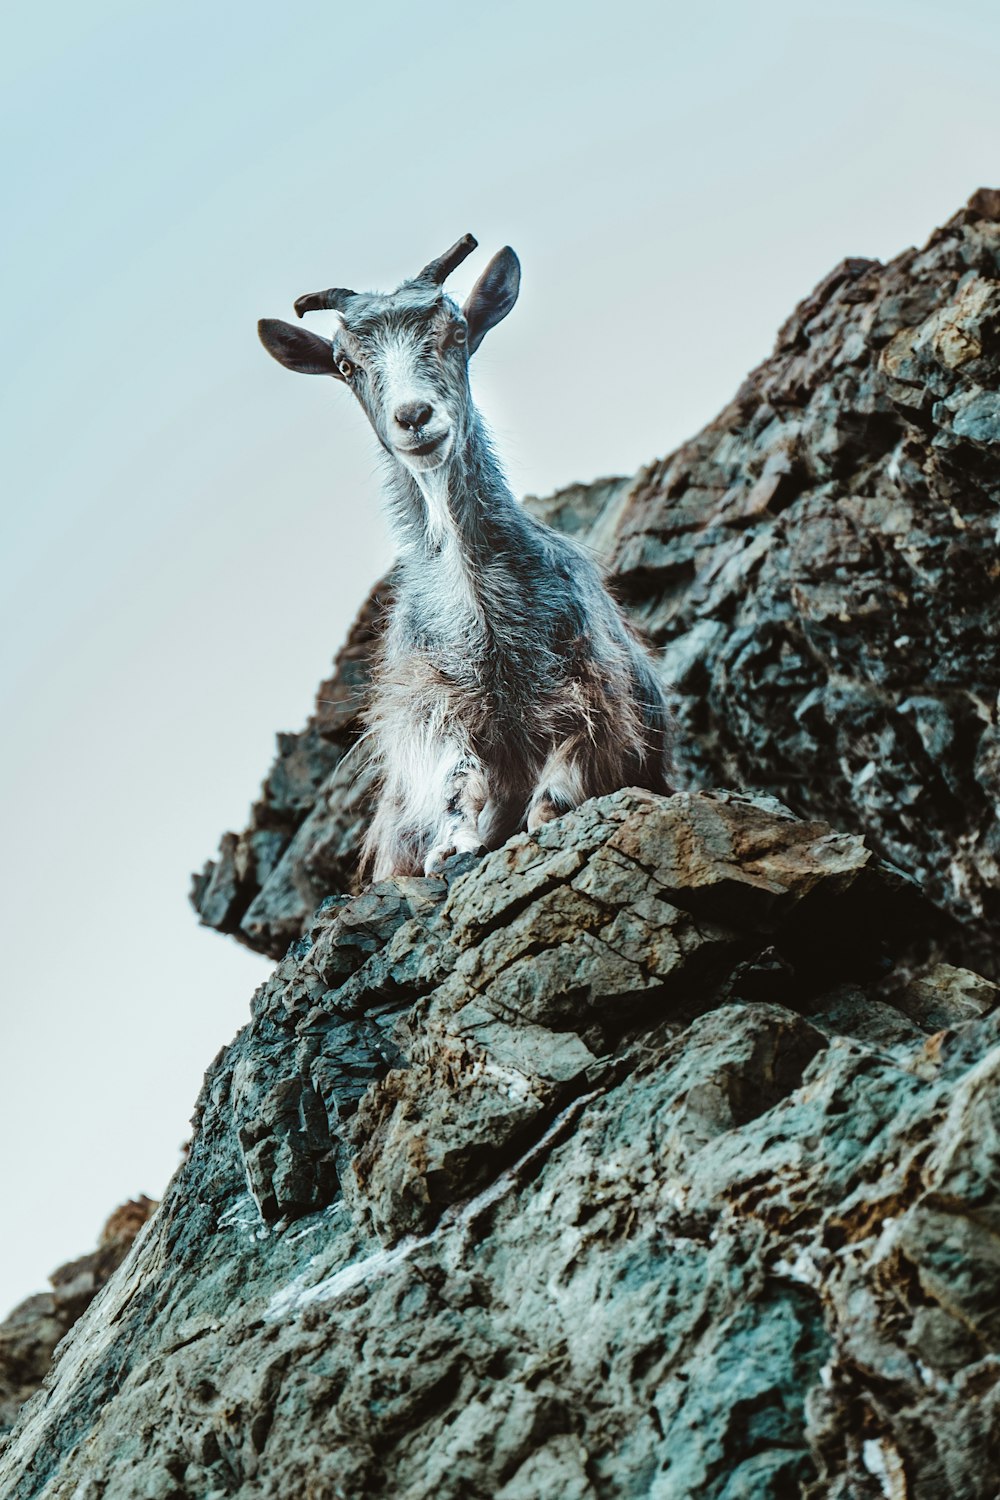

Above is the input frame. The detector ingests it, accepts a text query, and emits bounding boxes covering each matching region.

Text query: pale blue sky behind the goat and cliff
[0,0,1000,1311]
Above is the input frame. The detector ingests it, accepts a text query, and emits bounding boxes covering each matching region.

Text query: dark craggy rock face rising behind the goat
[193,191,1000,975]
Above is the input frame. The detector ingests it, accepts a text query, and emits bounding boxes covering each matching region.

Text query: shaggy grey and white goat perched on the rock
[258,234,669,881]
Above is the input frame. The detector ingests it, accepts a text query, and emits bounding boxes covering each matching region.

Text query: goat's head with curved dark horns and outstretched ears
[258,234,520,474]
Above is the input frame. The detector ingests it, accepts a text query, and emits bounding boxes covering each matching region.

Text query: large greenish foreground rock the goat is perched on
[0,791,1000,1500]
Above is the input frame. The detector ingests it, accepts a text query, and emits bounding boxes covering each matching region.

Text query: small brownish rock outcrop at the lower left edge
[0,1196,156,1434]
